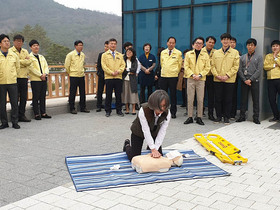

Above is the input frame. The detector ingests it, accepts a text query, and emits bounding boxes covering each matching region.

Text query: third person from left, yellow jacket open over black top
[29,39,51,120]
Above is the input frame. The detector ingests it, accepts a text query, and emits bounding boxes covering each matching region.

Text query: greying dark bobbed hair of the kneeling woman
[148,90,169,111]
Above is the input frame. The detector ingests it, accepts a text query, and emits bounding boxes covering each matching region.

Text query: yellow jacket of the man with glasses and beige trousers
[184,50,211,81]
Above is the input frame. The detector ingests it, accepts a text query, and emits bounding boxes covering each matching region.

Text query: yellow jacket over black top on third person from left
[29,52,49,81]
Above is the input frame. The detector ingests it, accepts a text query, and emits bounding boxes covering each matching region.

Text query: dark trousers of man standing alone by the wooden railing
[69,77,86,110]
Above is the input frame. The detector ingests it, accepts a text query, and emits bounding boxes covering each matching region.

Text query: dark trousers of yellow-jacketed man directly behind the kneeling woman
[159,77,178,114]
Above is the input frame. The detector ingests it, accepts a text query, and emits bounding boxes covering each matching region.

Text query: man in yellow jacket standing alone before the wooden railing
[64,40,90,114]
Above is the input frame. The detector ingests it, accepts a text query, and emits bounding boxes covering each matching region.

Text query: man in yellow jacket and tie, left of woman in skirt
[101,38,125,117]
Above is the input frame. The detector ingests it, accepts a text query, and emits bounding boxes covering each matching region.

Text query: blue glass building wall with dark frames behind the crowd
[123,0,252,55]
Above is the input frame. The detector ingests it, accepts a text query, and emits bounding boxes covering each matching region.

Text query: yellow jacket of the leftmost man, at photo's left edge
[0,49,20,85]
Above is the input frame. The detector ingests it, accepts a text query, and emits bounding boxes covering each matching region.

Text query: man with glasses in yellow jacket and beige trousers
[184,37,210,125]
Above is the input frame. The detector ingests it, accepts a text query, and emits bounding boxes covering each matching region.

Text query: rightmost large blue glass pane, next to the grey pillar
[231,3,252,54]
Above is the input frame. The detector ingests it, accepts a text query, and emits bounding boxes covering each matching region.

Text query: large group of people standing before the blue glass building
[97,33,280,125]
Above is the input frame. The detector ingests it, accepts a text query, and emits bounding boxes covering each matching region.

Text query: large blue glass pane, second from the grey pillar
[193,5,227,49]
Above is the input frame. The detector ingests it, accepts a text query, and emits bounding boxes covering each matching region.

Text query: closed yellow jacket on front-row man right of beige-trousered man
[211,48,239,83]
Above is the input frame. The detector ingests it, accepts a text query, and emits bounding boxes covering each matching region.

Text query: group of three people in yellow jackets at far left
[0,34,51,129]
